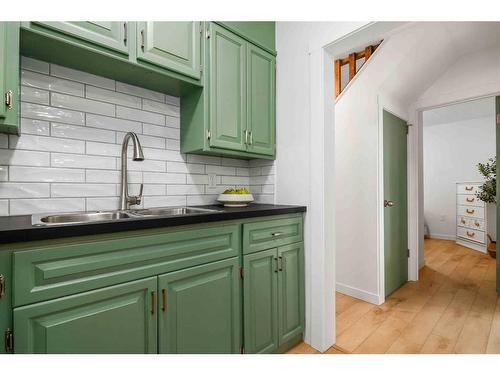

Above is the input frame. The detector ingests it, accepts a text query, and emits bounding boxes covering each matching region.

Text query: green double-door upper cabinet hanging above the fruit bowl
[181,22,276,159]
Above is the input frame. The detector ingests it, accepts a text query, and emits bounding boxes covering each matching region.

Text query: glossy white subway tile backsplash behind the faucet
[0,57,275,215]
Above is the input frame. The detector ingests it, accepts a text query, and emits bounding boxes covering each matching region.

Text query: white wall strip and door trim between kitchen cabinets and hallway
[275,22,365,351]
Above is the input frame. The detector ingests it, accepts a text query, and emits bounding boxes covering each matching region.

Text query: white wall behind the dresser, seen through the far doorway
[423,116,496,239]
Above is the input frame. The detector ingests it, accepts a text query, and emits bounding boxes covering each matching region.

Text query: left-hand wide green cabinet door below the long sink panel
[14,277,157,353]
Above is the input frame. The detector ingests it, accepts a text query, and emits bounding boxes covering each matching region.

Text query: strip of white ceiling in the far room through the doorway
[423,97,495,126]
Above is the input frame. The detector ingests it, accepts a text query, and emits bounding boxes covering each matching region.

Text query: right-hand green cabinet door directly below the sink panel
[158,257,241,354]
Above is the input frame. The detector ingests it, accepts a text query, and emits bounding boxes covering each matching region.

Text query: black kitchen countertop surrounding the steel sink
[0,204,306,244]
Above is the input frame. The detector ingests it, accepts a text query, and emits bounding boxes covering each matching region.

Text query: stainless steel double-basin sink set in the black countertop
[31,207,218,226]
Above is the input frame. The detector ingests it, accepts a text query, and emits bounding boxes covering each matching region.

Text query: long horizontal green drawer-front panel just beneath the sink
[13,224,241,306]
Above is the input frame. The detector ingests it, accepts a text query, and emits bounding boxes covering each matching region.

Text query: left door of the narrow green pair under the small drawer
[243,249,278,353]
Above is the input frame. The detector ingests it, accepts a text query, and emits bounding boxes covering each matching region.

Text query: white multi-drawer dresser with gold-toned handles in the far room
[457,182,488,253]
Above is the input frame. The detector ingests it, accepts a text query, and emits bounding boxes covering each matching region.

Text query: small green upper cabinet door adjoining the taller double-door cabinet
[137,21,201,79]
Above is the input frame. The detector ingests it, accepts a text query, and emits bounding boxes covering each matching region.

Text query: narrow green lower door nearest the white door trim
[278,243,304,345]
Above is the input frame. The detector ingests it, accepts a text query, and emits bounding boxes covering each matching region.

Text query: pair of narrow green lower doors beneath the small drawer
[243,243,304,353]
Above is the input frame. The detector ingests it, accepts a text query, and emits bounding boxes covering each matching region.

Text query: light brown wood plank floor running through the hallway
[289,240,500,353]
